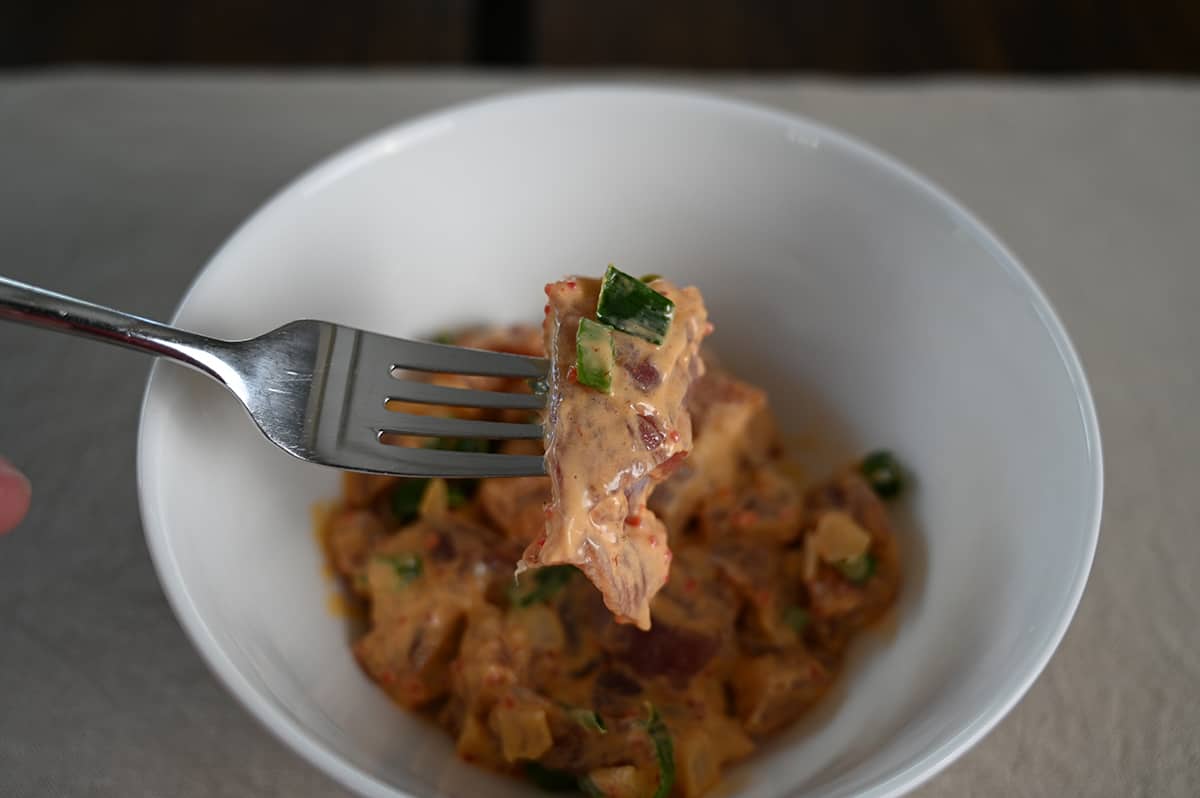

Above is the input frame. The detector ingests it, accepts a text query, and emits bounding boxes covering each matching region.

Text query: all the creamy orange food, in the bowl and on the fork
[322,269,902,798]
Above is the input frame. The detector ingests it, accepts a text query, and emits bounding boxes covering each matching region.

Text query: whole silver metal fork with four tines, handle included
[0,277,546,476]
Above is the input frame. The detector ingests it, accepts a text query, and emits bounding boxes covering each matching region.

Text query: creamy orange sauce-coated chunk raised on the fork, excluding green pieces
[528,277,710,629]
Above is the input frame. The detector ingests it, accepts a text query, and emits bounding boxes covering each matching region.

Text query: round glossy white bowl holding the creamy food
[138,88,1102,798]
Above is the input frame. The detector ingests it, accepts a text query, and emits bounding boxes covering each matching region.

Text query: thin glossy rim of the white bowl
[137,83,1104,798]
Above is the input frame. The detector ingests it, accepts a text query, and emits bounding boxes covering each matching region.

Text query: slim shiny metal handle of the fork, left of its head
[0,277,235,385]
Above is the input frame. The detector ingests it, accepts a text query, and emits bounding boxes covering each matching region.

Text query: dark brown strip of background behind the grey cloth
[0,0,1200,74]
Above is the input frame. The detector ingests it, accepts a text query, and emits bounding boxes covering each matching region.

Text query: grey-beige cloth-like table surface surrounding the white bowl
[0,71,1200,798]
